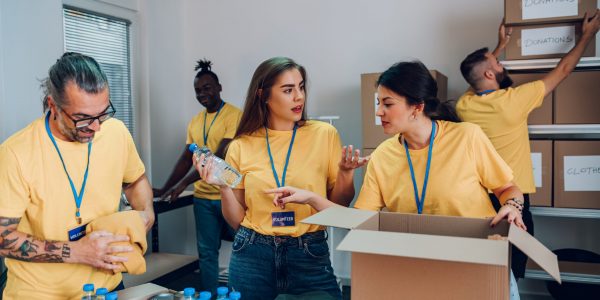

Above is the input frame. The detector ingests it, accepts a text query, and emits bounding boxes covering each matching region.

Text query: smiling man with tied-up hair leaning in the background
[154,59,242,294]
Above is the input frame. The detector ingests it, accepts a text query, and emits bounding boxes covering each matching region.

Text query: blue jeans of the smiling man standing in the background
[194,198,234,295]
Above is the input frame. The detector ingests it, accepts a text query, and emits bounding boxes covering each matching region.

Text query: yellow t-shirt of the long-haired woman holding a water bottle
[226,121,342,237]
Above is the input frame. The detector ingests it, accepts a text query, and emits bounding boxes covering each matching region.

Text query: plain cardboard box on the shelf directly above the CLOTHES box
[554,71,600,124]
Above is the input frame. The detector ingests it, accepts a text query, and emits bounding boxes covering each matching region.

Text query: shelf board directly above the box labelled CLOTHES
[527,124,600,139]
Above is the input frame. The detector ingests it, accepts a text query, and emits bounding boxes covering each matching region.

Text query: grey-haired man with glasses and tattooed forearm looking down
[0,52,154,299]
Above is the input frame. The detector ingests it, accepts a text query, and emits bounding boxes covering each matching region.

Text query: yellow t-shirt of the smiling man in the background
[185,103,242,200]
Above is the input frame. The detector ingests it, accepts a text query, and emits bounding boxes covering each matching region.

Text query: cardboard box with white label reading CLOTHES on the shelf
[554,141,600,209]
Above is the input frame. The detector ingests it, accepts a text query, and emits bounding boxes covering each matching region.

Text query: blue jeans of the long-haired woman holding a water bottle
[229,227,342,300]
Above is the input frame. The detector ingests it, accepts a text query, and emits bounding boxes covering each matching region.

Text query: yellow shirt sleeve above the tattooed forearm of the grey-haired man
[0,145,30,218]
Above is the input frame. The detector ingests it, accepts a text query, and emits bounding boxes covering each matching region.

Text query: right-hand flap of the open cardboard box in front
[508,224,561,283]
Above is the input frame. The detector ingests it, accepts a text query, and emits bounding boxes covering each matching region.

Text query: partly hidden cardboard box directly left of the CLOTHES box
[529,141,554,206]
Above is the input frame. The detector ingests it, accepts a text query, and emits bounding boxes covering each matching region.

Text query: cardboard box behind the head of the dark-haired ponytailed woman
[361,70,448,148]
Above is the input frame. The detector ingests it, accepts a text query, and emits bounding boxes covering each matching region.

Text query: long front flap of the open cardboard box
[337,229,509,266]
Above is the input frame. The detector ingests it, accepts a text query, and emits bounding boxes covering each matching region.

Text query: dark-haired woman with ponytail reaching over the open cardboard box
[269,61,525,299]
